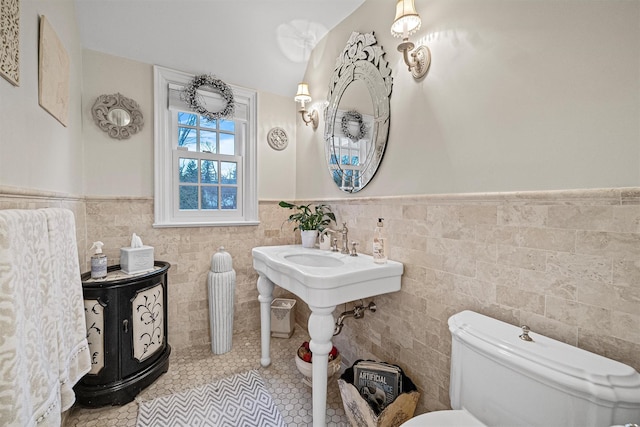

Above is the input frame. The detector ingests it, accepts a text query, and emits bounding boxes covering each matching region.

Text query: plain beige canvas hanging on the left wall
[38,16,69,126]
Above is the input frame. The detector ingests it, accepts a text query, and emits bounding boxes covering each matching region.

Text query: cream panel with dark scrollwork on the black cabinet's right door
[131,283,164,362]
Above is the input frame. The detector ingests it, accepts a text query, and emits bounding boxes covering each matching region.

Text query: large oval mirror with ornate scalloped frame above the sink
[324,32,393,193]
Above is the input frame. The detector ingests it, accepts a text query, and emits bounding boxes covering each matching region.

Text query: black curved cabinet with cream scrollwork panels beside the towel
[74,261,171,407]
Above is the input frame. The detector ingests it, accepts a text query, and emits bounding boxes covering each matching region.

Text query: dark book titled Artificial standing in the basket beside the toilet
[353,360,402,415]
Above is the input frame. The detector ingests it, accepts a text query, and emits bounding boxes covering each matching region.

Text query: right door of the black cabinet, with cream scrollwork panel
[120,275,167,378]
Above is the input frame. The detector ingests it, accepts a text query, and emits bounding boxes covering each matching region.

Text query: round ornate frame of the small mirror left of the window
[91,93,144,139]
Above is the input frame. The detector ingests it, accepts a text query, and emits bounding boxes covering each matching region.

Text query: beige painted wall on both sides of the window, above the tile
[82,49,296,201]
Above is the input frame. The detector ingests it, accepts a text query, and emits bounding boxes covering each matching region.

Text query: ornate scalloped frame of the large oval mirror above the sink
[324,31,393,193]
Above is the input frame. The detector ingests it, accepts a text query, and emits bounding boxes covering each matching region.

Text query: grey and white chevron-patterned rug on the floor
[136,370,286,427]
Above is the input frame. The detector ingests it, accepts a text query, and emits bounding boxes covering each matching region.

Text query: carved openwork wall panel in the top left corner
[0,0,20,86]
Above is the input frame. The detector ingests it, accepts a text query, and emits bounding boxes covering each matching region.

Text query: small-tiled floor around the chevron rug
[64,327,349,427]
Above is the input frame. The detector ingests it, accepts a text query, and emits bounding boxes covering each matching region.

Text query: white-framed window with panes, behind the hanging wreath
[154,66,258,227]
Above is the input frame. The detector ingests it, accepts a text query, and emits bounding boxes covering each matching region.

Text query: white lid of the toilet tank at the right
[449,310,640,404]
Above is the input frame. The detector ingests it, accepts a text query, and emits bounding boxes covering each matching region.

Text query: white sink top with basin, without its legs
[252,245,403,307]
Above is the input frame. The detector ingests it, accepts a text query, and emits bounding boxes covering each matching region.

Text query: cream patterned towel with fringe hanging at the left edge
[0,209,91,427]
